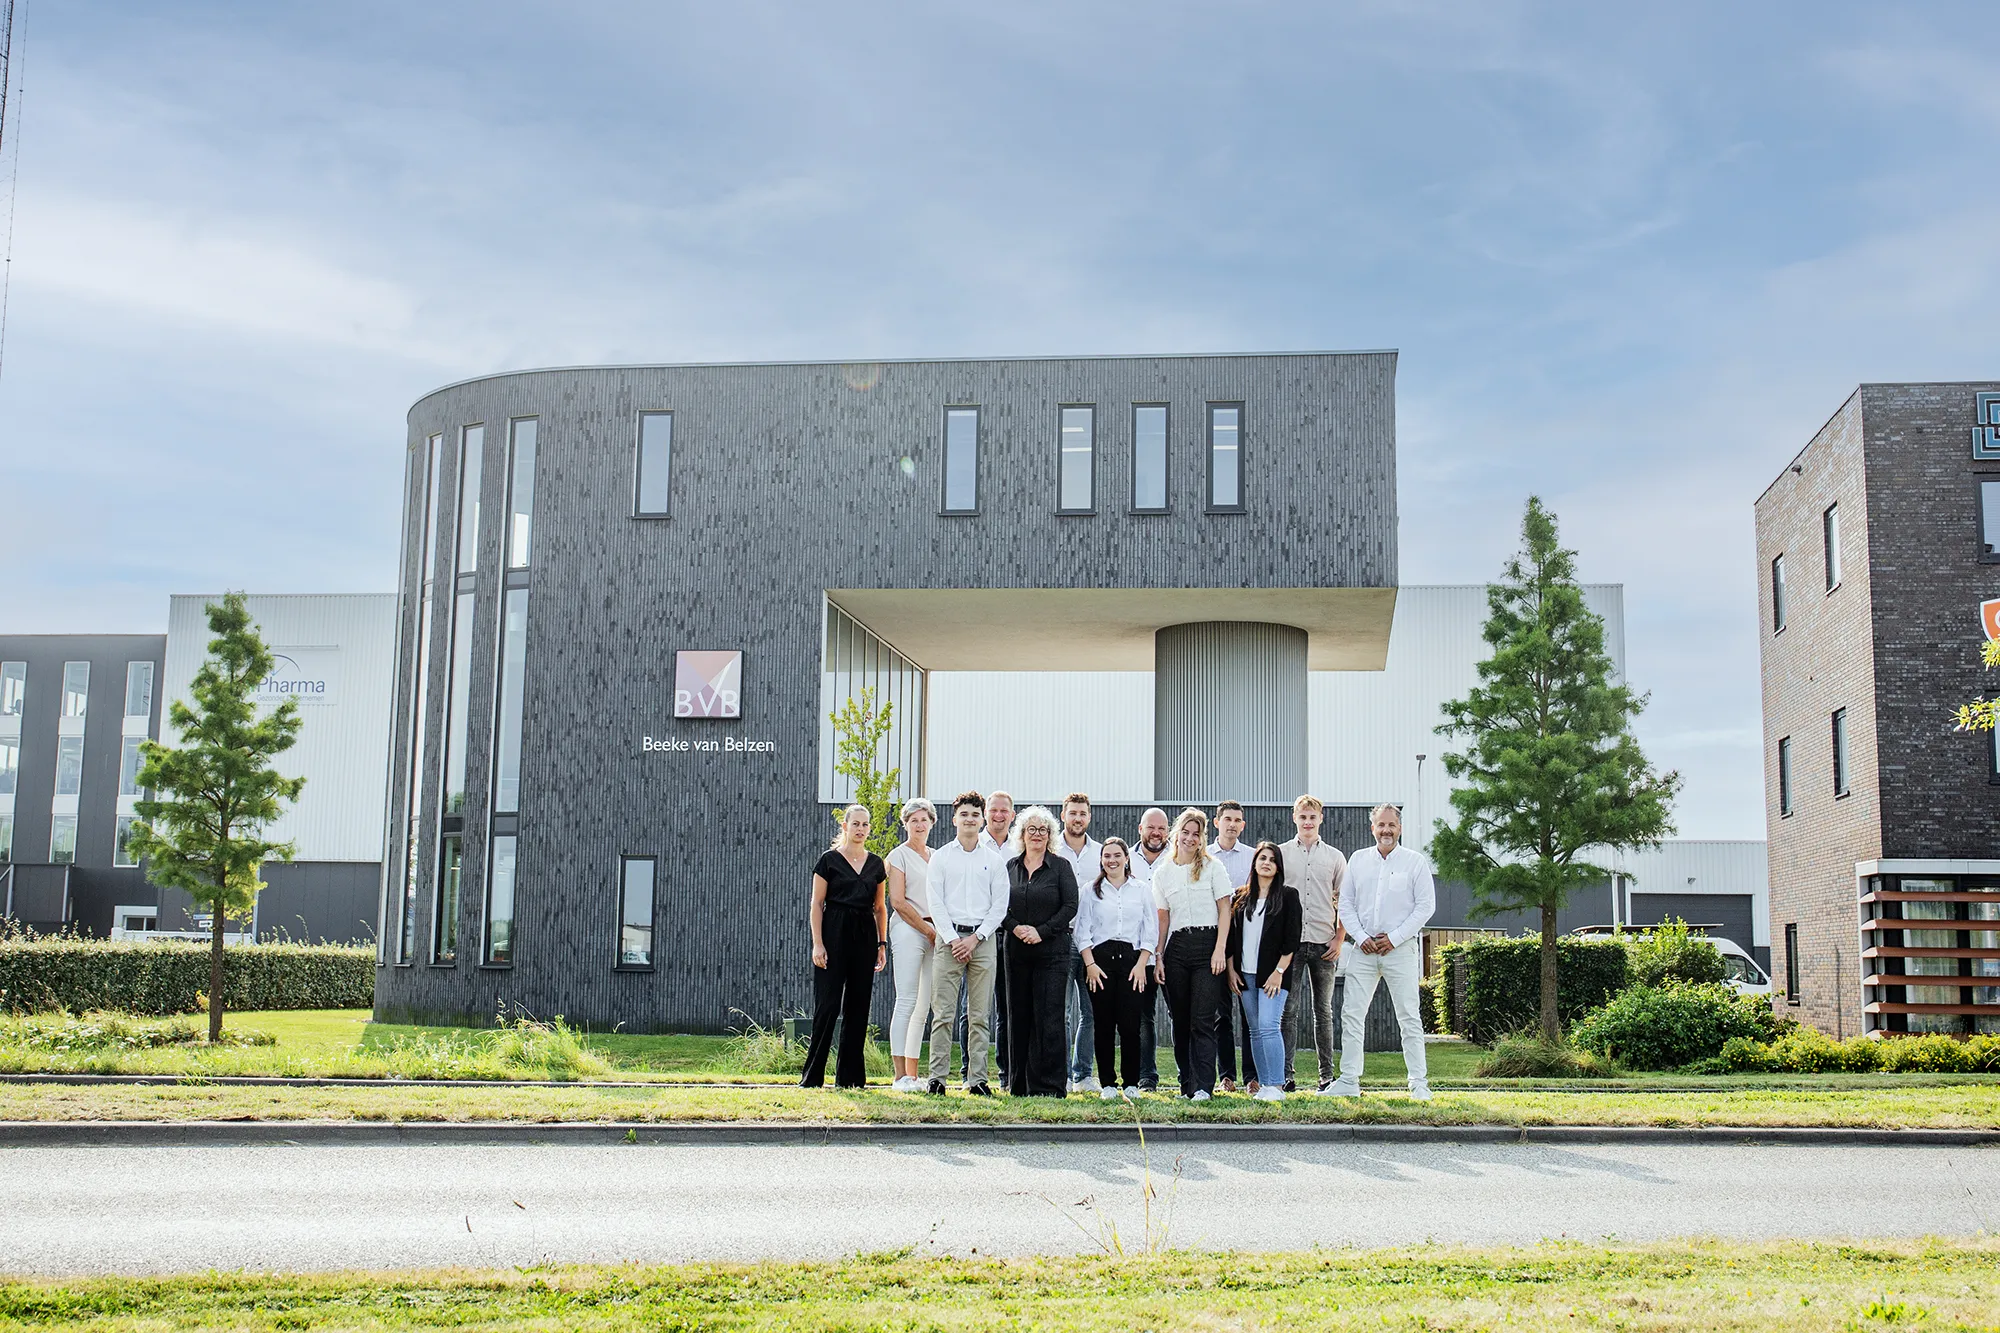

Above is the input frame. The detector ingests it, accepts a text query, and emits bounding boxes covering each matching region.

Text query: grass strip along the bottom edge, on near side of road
[0,1239,2000,1333]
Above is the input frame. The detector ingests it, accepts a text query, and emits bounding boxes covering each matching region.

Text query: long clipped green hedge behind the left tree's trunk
[0,939,376,1015]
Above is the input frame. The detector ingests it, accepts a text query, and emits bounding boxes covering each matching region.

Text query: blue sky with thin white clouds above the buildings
[0,0,2000,837]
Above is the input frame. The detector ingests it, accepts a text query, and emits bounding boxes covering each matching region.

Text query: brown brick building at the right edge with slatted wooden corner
[1756,382,2000,1035]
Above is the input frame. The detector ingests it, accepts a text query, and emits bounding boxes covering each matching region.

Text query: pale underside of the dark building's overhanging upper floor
[826,588,1396,671]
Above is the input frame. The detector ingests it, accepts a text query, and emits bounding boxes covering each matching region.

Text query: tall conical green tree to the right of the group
[1430,496,1680,1041]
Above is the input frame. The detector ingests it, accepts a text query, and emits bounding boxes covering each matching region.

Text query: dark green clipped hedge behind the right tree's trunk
[1436,935,1628,1047]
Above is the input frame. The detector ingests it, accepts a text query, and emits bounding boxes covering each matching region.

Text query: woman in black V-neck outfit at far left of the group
[798,805,888,1087]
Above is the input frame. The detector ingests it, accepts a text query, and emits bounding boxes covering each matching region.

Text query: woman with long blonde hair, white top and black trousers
[1152,809,1236,1101]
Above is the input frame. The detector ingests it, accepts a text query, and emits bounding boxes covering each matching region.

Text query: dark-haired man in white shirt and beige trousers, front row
[926,791,1008,1097]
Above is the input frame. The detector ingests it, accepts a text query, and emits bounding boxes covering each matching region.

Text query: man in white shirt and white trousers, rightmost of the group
[1324,805,1438,1101]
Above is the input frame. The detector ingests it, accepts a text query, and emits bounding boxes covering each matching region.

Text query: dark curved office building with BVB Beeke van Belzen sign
[376,352,1396,1031]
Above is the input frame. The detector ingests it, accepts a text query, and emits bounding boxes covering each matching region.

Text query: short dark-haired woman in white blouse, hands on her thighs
[1076,837,1160,1101]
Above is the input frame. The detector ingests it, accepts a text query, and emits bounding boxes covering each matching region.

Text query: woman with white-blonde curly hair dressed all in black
[1000,805,1076,1097]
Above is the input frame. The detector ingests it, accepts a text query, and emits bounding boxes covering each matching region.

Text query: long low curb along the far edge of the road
[0,1121,2000,1149]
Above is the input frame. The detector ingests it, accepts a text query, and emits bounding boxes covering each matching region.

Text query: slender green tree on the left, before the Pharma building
[130,592,306,1041]
